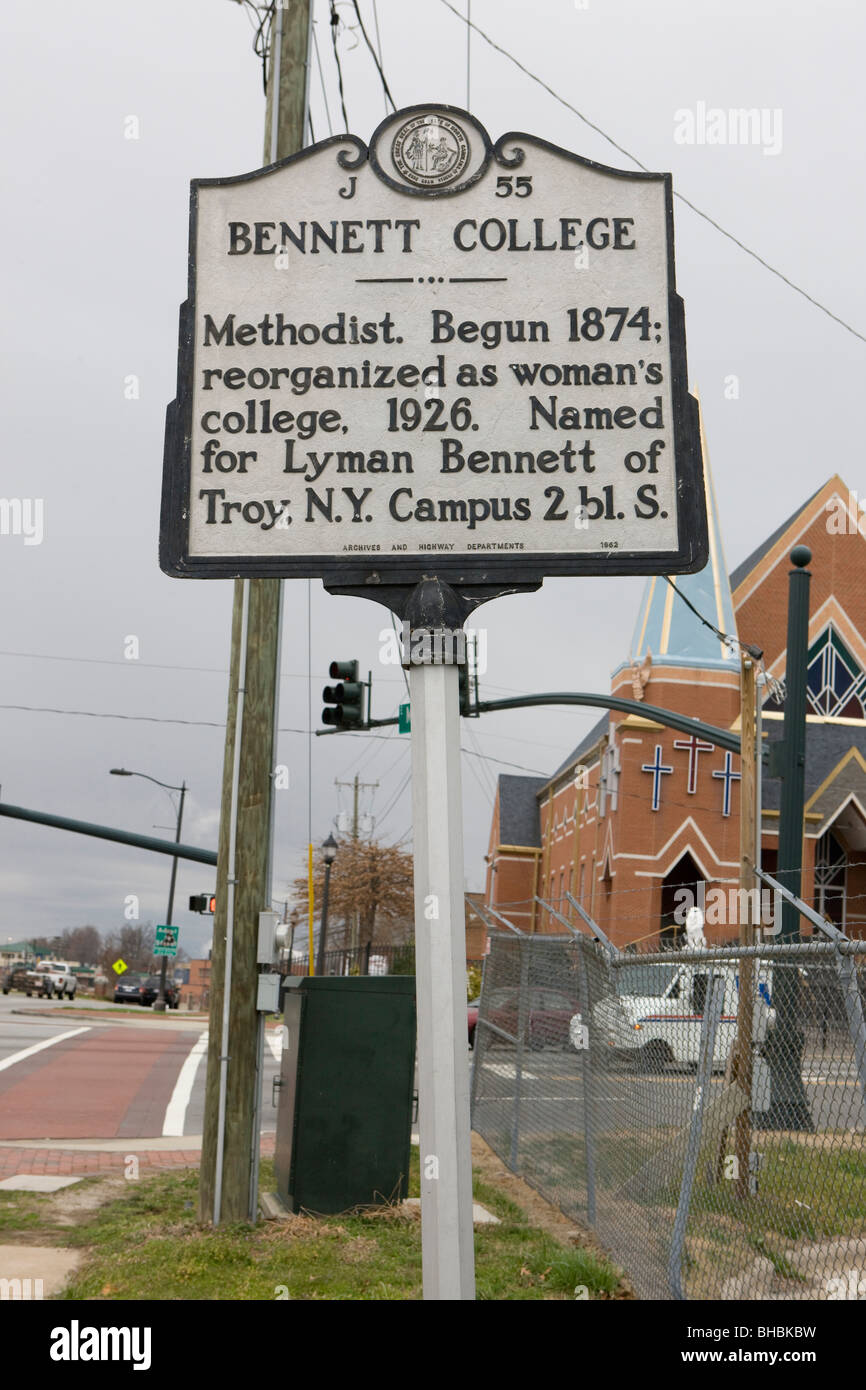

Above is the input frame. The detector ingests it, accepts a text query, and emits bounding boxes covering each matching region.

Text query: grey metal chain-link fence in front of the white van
[473,933,866,1300]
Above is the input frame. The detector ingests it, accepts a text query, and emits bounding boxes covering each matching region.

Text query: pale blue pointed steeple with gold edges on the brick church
[631,400,737,670]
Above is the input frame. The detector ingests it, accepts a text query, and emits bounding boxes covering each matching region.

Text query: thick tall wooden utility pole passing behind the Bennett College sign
[199,0,310,1225]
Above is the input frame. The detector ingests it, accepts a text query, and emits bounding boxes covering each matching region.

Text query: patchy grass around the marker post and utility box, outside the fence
[0,1151,620,1301]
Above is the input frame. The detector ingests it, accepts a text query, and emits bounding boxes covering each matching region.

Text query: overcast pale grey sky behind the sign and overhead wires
[0,0,866,955]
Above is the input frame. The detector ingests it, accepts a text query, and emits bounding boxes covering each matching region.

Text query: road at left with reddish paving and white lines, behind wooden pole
[0,994,279,1143]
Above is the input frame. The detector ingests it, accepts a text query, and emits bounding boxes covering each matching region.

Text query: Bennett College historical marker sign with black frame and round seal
[161,106,706,587]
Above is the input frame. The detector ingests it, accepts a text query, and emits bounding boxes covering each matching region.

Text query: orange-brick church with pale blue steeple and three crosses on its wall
[485,450,866,947]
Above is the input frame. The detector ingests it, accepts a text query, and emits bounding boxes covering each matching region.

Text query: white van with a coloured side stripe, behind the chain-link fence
[592,956,776,1070]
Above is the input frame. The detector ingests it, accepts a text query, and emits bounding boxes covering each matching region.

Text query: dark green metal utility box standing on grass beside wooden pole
[275,974,416,1213]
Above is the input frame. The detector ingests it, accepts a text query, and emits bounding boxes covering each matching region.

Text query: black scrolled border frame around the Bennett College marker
[160,101,709,586]
